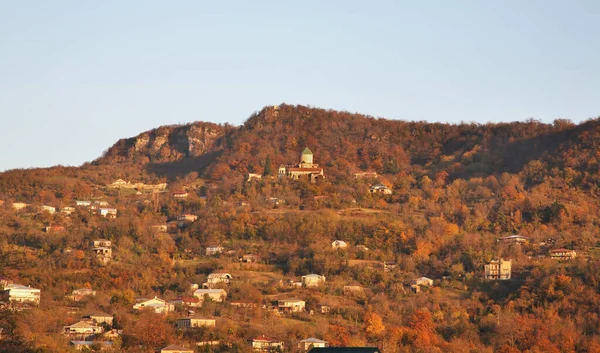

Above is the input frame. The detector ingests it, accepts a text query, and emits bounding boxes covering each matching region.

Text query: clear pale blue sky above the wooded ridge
[0,0,600,171]
